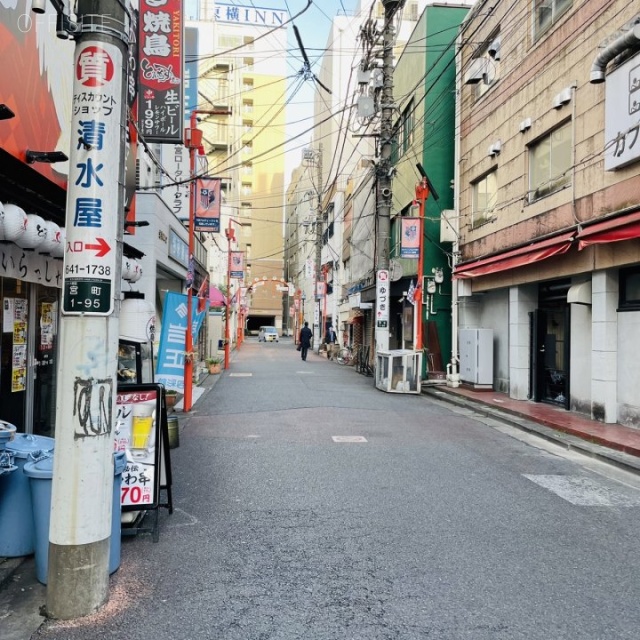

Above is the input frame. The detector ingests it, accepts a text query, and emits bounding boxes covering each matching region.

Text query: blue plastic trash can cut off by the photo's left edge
[0,433,55,558]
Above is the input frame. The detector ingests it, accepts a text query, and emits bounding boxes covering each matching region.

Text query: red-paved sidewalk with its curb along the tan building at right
[422,385,640,473]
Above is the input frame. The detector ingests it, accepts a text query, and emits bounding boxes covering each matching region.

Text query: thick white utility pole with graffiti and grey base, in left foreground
[46,0,129,619]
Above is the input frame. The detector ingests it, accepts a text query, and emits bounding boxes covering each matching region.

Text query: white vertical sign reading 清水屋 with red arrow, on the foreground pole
[62,40,124,316]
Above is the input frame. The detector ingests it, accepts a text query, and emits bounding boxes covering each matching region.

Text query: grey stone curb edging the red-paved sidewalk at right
[422,387,640,475]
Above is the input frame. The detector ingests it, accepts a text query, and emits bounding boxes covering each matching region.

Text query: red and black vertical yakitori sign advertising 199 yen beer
[138,0,183,143]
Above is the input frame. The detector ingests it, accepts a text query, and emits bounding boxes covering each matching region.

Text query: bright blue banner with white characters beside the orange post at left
[155,292,209,393]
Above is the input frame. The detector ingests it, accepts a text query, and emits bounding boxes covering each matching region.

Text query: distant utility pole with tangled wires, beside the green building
[375,0,404,351]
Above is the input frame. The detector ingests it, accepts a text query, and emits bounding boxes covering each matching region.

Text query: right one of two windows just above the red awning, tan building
[529,122,573,202]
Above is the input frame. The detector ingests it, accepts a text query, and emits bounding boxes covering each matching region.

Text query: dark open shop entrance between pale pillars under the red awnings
[529,281,571,409]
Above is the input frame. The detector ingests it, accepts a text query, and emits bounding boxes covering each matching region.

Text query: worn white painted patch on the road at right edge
[523,473,640,507]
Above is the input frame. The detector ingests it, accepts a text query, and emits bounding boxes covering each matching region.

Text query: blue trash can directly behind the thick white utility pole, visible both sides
[24,451,126,584]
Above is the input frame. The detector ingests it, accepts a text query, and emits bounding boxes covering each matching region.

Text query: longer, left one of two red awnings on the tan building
[453,231,575,278]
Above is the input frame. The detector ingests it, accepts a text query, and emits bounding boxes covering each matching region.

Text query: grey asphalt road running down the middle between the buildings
[28,340,640,640]
